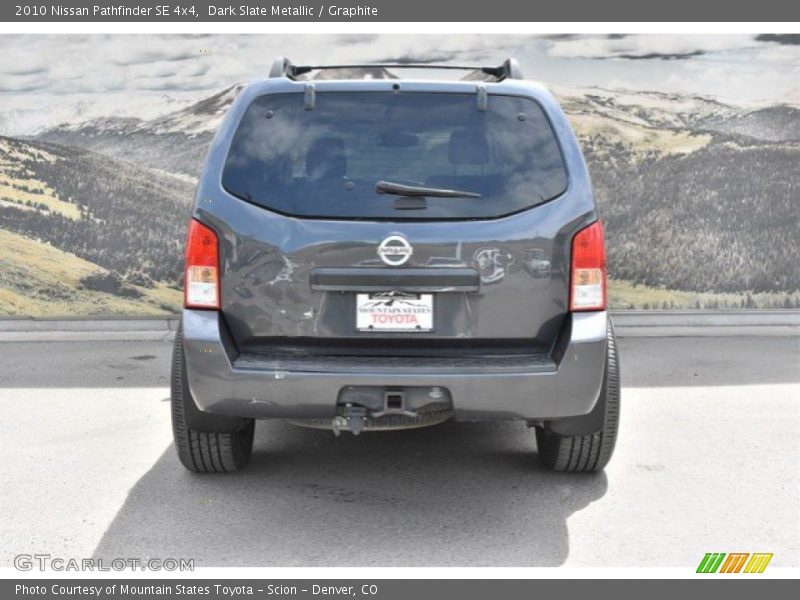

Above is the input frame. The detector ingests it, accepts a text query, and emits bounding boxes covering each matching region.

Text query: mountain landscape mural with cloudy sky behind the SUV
[0,34,800,315]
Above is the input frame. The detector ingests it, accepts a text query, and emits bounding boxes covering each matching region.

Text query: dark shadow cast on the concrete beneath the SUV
[95,422,607,567]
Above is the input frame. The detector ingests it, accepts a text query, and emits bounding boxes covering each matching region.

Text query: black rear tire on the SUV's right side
[536,322,620,473]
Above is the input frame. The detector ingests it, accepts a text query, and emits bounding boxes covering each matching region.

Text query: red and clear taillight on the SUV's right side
[569,221,606,310]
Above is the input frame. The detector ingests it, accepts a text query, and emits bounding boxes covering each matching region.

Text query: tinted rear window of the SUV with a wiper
[222,92,567,220]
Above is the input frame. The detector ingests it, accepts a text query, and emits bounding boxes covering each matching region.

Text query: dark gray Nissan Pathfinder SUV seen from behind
[172,59,619,472]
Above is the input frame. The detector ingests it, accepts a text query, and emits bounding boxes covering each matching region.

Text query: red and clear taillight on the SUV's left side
[183,219,219,310]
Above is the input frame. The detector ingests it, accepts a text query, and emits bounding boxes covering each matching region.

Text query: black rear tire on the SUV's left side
[171,326,255,473]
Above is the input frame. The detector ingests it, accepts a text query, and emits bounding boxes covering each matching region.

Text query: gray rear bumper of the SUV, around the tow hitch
[182,310,607,421]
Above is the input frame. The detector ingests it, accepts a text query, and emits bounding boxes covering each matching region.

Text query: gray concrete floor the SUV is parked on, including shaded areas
[0,335,800,569]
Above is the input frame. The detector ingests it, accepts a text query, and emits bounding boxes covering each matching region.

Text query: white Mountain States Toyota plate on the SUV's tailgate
[356,292,433,331]
